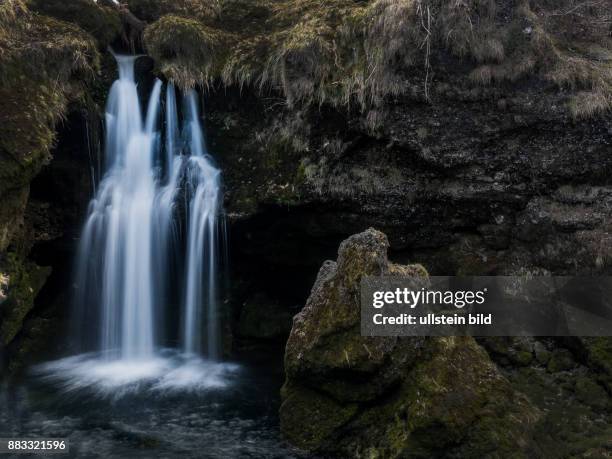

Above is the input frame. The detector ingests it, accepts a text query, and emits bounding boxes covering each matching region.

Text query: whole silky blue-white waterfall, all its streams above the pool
[75,56,225,360]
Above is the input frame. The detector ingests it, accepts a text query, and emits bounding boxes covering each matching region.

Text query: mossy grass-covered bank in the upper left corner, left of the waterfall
[0,0,99,193]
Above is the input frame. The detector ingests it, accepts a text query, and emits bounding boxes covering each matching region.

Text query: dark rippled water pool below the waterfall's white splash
[0,350,304,458]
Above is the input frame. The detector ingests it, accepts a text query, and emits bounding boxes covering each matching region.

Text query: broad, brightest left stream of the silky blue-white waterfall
[72,56,161,359]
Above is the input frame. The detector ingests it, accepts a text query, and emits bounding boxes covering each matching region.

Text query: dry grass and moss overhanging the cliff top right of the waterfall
[135,0,612,117]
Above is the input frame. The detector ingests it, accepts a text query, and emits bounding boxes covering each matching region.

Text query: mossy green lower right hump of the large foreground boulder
[327,338,539,458]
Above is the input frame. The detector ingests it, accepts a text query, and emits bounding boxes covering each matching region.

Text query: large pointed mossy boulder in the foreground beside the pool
[280,229,540,458]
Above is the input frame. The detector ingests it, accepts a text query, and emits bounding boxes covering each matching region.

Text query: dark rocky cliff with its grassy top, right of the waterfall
[124,0,612,280]
